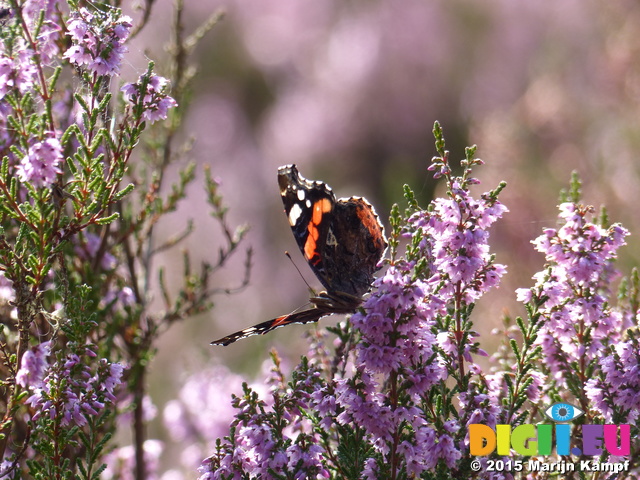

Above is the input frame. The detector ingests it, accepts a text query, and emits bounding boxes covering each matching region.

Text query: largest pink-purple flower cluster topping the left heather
[64,7,133,75]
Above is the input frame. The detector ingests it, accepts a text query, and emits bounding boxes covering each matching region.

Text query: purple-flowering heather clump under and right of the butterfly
[190,123,640,480]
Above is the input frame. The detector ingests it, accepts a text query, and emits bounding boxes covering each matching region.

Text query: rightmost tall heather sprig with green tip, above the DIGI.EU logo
[504,174,640,466]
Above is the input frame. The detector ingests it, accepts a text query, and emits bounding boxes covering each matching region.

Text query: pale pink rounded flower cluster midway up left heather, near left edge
[17,135,62,187]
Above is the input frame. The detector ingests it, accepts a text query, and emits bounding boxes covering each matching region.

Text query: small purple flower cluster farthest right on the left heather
[122,74,178,123]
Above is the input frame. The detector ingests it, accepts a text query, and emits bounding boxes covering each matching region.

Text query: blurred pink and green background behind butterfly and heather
[123,0,640,478]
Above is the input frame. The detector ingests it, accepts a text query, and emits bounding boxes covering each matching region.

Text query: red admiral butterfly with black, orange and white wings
[211,165,387,345]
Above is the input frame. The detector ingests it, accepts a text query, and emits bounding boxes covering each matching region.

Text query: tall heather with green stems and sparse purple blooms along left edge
[0,0,250,480]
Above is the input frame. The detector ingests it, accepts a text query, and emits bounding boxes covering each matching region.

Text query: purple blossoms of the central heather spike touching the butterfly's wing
[328,164,507,476]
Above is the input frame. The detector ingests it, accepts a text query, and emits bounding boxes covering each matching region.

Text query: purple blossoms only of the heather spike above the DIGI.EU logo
[518,184,630,411]
